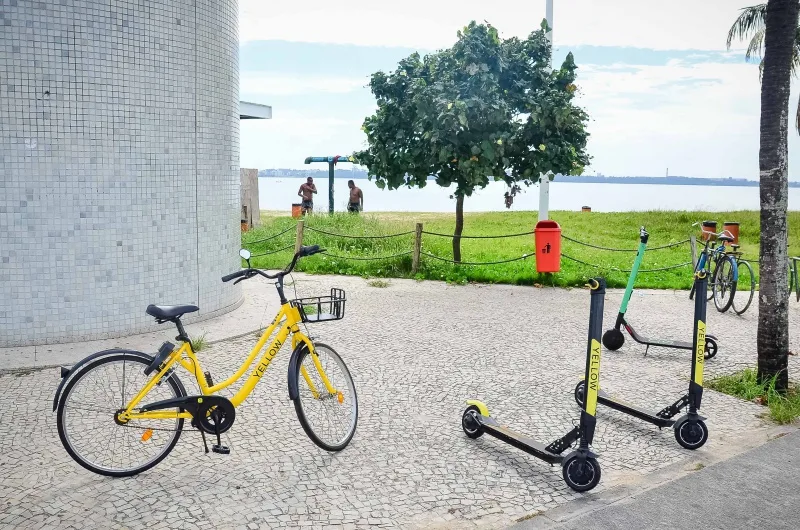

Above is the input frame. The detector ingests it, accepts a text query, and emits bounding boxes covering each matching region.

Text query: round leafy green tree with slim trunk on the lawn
[354,21,589,262]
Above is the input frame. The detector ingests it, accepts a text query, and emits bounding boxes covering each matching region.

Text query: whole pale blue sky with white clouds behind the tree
[239,0,800,180]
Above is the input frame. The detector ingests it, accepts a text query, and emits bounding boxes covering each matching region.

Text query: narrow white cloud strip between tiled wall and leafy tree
[240,71,369,96]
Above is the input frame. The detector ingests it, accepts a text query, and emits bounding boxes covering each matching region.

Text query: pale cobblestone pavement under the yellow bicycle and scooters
[0,276,800,529]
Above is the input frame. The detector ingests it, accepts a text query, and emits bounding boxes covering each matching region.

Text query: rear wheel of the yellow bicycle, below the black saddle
[57,353,186,477]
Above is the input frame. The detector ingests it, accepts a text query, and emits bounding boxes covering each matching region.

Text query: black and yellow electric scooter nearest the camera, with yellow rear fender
[461,278,606,492]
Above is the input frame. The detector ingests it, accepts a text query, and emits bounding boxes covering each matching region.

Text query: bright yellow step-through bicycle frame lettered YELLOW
[118,302,336,421]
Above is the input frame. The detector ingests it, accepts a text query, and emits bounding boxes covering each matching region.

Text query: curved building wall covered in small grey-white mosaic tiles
[0,0,242,347]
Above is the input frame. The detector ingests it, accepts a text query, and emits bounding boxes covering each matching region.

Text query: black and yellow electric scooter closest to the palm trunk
[575,271,708,449]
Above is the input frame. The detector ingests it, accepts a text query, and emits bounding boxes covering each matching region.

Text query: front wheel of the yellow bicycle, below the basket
[292,343,358,451]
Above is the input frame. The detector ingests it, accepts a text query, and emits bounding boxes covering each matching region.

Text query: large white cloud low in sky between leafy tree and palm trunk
[580,58,780,179]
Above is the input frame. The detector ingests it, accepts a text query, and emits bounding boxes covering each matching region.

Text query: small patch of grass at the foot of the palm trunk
[706,368,800,425]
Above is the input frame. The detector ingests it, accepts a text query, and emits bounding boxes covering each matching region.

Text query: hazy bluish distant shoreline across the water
[258,168,800,188]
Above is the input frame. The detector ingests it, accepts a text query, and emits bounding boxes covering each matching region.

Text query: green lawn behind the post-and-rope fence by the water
[242,211,800,289]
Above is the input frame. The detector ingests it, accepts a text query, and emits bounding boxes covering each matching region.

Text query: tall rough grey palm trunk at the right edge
[758,0,800,390]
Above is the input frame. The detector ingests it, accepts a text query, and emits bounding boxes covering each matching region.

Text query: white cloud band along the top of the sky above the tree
[239,0,747,50]
